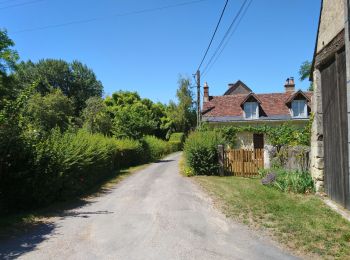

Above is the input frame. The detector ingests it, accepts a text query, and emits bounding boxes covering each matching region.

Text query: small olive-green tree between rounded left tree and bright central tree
[82,97,112,135]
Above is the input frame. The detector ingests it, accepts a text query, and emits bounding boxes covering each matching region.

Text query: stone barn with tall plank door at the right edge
[310,0,350,209]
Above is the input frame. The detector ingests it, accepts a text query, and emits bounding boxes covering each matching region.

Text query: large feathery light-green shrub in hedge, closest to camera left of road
[33,131,118,204]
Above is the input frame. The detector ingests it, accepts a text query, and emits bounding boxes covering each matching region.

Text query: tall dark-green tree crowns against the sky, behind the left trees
[15,59,103,115]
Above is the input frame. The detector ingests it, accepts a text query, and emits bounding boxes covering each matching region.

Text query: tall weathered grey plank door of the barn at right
[321,47,350,208]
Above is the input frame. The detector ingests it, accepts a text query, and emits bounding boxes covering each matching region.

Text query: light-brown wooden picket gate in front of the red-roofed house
[224,149,264,177]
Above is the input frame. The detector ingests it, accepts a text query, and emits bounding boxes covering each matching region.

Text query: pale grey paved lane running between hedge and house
[0,154,293,260]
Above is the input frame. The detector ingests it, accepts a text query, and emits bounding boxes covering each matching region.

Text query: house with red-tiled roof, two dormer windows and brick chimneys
[202,78,312,152]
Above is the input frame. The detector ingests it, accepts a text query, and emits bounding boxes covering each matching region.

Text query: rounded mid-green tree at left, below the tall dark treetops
[23,89,74,133]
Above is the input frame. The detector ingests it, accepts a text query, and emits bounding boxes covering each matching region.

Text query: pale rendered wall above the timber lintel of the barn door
[316,0,345,53]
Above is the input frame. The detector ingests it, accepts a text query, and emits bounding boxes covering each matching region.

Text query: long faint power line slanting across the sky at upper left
[13,0,208,34]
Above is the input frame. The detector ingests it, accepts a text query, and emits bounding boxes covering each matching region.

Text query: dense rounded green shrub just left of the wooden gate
[184,131,224,175]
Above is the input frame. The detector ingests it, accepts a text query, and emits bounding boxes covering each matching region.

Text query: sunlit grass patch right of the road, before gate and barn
[194,176,350,259]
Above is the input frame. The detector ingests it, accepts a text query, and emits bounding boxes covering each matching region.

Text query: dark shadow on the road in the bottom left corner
[0,223,55,260]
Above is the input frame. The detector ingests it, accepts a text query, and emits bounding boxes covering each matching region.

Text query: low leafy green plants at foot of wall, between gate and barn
[260,169,314,194]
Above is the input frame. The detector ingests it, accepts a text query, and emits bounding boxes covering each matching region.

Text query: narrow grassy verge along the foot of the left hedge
[0,164,149,239]
